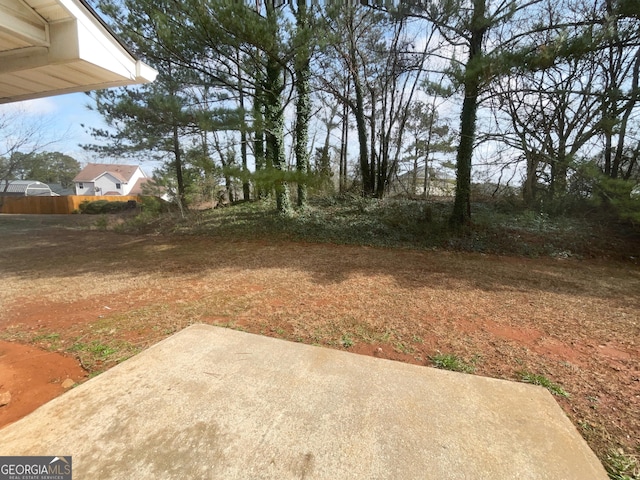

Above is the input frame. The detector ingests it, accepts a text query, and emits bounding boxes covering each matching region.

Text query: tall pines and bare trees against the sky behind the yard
[86,0,640,226]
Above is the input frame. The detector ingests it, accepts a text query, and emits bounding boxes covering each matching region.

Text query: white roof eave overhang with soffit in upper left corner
[0,0,158,103]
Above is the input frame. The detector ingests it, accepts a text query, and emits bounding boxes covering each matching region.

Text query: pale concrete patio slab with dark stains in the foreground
[0,325,607,480]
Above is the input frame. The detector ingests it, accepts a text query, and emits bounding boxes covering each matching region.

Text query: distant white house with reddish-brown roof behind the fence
[73,163,150,196]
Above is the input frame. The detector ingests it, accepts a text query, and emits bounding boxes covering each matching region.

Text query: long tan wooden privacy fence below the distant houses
[0,195,140,214]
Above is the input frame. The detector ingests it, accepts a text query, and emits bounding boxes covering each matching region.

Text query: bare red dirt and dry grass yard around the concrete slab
[0,215,640,468]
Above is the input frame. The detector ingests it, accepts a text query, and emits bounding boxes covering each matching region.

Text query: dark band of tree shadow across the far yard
[0,215,640,306]
